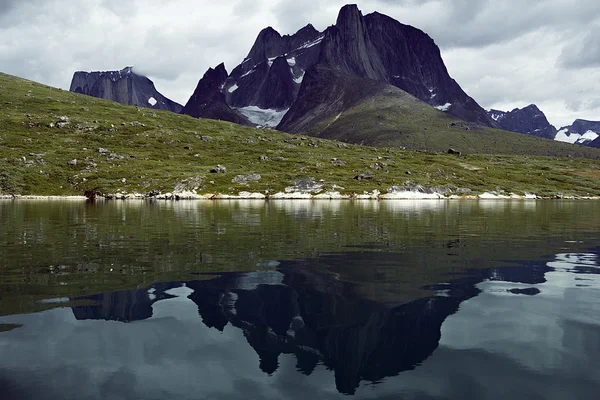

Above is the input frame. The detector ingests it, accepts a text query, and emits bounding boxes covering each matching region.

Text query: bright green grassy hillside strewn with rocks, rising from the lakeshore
[0,74,600,196]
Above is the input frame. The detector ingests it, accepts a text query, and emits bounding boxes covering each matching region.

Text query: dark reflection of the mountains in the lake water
[67,253,572,394]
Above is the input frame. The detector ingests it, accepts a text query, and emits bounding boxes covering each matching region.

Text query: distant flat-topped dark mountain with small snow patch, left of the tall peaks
[70,67,182,113]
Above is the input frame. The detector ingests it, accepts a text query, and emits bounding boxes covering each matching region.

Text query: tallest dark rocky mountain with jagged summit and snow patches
[184,5,500,133]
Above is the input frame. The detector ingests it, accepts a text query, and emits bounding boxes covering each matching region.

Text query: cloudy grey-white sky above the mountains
[0,0,600,127]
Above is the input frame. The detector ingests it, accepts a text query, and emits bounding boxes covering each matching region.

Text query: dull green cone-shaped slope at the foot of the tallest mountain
[307,85,599,158]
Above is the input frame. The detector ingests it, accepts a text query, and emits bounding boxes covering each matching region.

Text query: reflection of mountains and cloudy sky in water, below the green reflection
[0,253,600,399]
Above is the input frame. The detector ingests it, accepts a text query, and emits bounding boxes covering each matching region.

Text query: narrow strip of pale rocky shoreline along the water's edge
[0,190,600,201]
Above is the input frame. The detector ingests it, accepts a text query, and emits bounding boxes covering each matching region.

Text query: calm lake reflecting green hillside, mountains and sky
[0,200,600,400]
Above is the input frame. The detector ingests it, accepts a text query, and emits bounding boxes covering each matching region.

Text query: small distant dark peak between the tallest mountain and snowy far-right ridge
[488,104,556,139]
